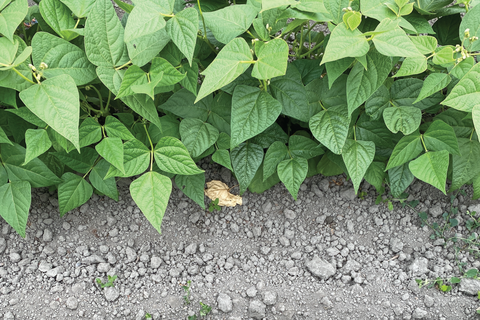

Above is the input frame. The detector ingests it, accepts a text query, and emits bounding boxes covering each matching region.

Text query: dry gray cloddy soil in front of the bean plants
[0,162,480,320]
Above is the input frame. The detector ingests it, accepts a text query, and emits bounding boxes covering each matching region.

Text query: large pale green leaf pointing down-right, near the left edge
[20,74,80,150]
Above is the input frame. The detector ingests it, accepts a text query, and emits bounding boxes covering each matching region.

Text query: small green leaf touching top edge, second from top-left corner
[39,0,78,41]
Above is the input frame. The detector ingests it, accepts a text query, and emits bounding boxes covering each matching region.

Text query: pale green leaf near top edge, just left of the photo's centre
[203,4,258,44]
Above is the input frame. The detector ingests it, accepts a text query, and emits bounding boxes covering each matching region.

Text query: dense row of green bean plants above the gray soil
[0,0,480,237]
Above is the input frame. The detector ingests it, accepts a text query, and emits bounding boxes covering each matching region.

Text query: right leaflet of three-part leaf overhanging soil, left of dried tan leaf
[155,137,203,175]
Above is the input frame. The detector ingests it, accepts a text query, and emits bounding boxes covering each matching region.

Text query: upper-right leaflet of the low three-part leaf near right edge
[423,120,460,155]
